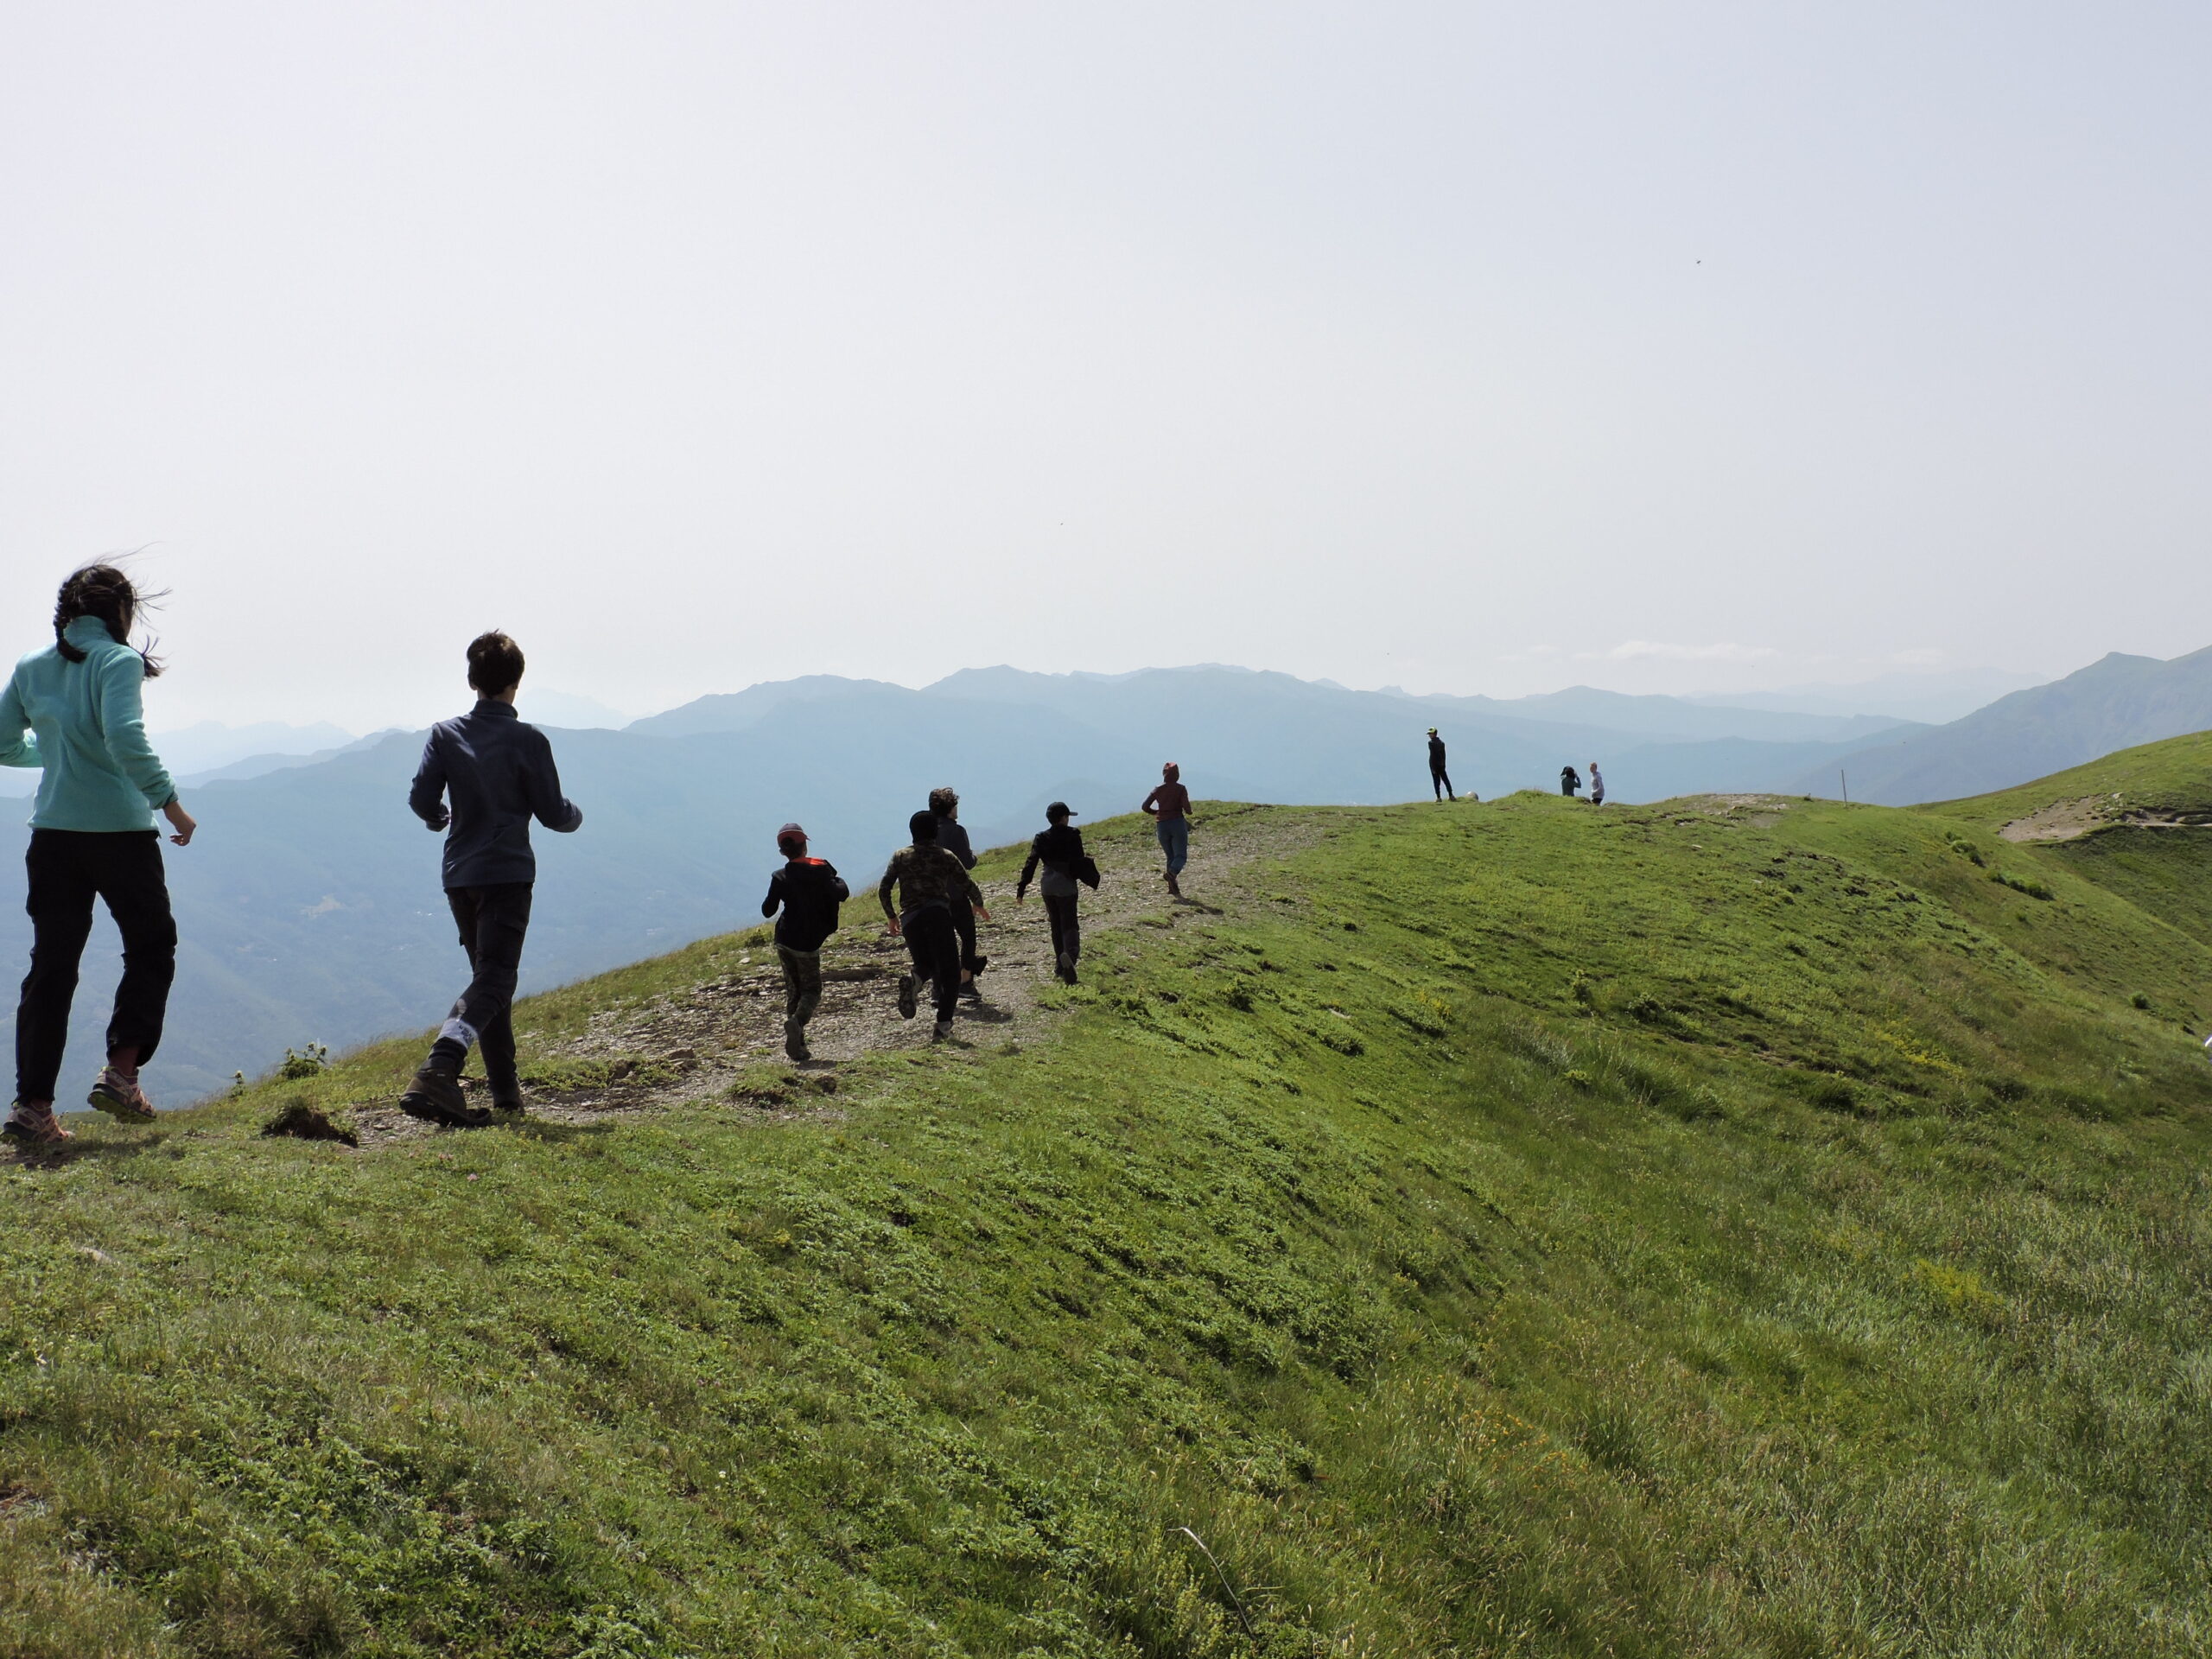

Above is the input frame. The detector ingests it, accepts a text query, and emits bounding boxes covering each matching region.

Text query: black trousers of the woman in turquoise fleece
[16,830,177,1099]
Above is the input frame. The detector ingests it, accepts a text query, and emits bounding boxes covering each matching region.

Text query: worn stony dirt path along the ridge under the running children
[336,807,1320,1146]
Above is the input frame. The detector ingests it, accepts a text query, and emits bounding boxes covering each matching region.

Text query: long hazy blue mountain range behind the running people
[0,668,1991,1097]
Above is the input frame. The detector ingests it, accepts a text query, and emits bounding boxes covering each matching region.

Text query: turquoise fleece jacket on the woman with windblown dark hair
[0,617,177,832]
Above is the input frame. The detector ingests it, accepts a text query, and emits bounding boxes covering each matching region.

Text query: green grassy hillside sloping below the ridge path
[0,765,2212,1659]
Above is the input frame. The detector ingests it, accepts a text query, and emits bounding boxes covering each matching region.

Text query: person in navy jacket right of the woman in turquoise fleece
[400,632,584,1128]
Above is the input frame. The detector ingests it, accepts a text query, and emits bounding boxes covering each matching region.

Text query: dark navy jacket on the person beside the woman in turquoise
[407,696,584,887]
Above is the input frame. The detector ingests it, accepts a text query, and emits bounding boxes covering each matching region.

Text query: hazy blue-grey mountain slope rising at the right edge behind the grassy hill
[1794,648,2212,805]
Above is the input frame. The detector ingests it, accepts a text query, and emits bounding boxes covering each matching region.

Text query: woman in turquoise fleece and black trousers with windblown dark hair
[0,564,194,1146]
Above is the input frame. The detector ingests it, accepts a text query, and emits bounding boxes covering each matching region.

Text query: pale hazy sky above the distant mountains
[0,0,2212,730]
